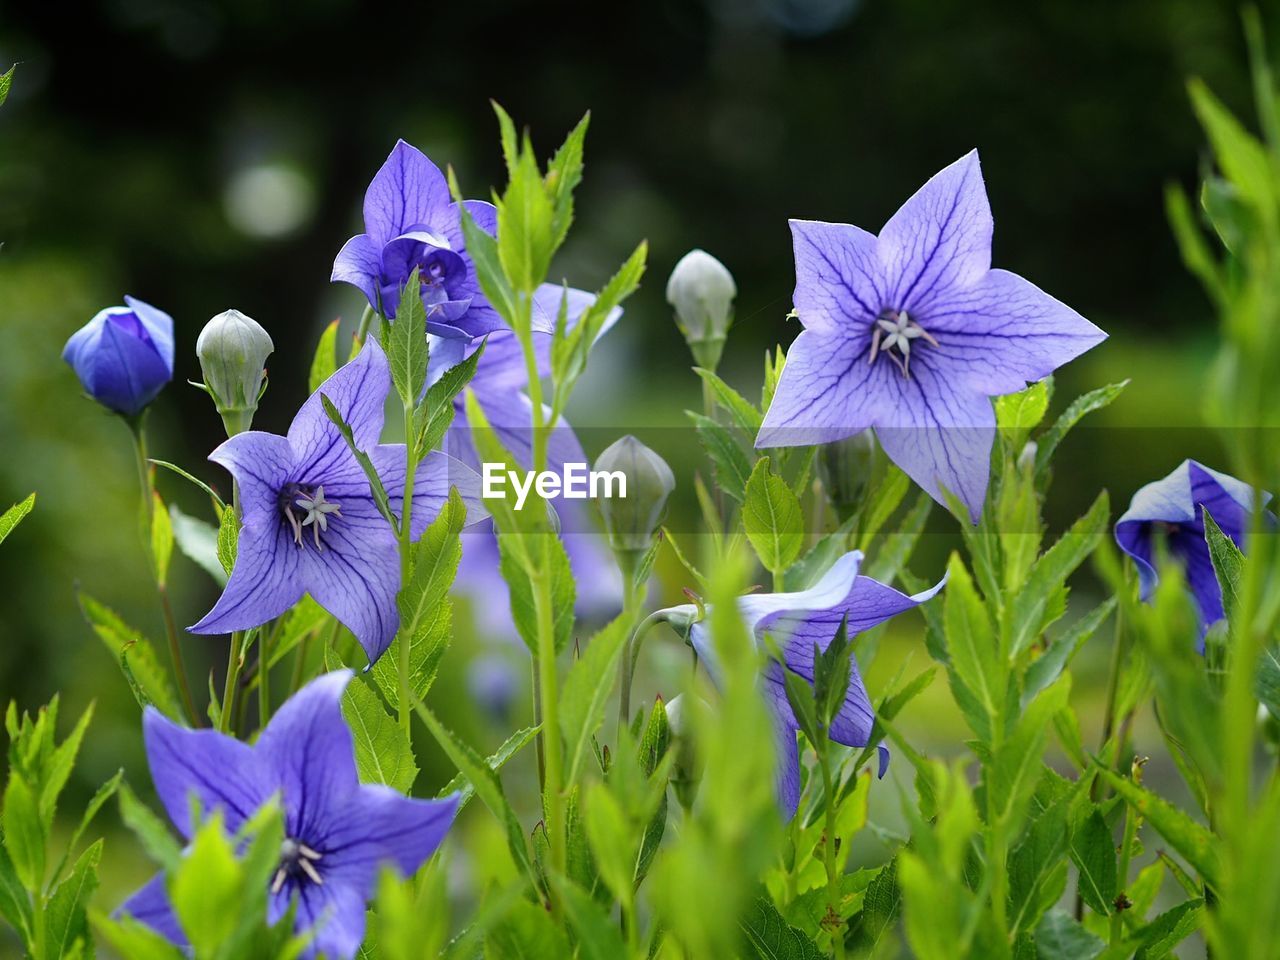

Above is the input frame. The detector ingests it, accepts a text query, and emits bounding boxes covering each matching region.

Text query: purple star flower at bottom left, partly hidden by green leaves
[120,669,458,960]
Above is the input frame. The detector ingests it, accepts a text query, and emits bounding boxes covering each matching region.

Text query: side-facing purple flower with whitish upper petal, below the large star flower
[669,550,946,819]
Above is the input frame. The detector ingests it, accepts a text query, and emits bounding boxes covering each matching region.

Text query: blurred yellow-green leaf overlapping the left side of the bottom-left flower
[169,813,244,956]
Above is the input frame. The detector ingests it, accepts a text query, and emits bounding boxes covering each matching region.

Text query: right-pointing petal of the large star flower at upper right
[913,270,1107,394]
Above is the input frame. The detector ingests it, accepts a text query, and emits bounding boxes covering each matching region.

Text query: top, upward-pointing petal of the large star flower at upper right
[878,150,992,314]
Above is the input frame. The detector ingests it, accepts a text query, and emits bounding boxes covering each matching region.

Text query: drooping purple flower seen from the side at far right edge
[1115,460,1270,649]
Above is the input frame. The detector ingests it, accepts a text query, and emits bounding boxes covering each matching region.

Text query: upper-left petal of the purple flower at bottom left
[140,707,273,839]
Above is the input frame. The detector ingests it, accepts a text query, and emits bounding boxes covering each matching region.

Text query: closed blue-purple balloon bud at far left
[63,297,173,416]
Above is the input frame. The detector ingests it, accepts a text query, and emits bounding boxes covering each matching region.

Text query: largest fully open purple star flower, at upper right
[755,151,1106,522]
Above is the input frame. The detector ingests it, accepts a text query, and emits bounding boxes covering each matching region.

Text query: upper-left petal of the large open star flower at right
[790,220,888,337]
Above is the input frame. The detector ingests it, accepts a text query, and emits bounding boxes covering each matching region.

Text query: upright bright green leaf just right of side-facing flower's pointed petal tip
[943,553,1006,736]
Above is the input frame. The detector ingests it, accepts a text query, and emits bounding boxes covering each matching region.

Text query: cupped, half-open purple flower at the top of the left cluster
[332,140,504,338]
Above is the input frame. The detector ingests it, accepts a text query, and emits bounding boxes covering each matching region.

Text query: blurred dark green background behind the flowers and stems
[0,0,1276,936]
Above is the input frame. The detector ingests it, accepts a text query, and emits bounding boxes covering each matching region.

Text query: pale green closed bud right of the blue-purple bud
[196,310,275,434]
